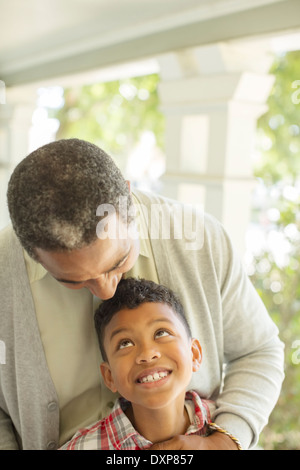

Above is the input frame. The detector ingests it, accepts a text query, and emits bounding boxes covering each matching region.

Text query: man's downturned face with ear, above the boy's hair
[35,214,139,300]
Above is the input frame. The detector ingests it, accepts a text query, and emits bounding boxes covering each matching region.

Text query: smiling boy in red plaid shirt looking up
[61,278,239,450]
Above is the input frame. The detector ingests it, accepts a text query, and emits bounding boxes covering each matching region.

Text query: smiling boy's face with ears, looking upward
[100,303,202,409]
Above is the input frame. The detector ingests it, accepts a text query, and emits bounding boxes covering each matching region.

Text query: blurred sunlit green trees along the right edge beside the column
[251,51,300,450]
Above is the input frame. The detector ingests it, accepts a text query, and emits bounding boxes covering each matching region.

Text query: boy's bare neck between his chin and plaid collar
[125,392,190,443]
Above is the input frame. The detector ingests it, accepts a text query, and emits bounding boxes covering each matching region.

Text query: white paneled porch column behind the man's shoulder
[159,43,274,255]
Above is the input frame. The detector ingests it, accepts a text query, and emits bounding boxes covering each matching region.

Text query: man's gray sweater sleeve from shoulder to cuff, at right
[212,224,284,448]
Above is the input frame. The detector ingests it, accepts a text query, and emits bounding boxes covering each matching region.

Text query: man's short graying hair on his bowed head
[7,139,133,258]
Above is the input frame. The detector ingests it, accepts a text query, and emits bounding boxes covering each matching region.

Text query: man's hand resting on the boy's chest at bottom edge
[148,432,238,450]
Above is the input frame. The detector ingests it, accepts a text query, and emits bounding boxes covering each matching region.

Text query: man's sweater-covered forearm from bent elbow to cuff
[213,338,283,448]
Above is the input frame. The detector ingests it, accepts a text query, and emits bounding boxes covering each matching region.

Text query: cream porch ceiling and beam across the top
[0,0,300,86]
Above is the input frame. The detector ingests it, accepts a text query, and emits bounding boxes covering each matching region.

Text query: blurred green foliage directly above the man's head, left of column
[51,74,165,173]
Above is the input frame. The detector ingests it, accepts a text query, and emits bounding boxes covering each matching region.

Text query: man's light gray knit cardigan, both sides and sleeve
[0,192,283,449]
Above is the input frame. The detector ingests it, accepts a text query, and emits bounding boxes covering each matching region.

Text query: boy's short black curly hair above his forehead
[94,278,192,362]
